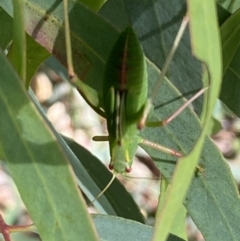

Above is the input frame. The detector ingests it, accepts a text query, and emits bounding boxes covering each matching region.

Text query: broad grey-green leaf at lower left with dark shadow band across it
[0,49,97,241]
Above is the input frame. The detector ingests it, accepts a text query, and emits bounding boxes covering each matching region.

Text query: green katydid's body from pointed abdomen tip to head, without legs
[103,27,148,173]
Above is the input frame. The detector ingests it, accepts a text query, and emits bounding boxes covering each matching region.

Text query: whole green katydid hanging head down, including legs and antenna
[64,0,206,201]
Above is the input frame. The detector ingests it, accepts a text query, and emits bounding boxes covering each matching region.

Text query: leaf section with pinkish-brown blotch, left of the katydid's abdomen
[0,0,119,90]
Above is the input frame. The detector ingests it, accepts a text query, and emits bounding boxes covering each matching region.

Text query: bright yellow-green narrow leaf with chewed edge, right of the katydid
[153,1,221,241]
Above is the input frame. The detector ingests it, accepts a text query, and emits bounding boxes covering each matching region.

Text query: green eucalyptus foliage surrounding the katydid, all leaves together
[0,0,240,241]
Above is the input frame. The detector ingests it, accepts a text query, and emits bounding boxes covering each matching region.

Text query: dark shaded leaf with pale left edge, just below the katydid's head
[29,90,145,223]
